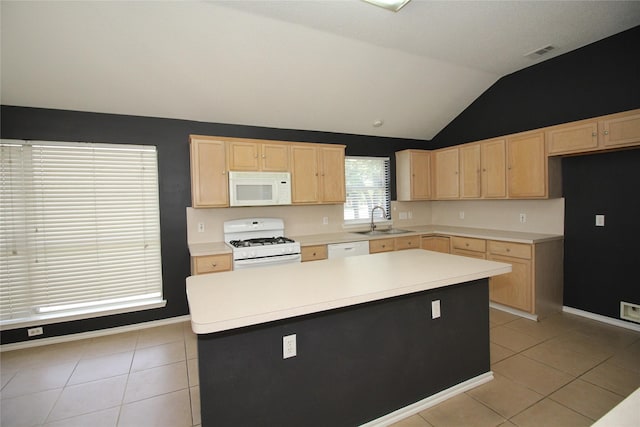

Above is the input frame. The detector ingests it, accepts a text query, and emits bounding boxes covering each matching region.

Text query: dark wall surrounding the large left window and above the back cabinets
[0,106,424,344]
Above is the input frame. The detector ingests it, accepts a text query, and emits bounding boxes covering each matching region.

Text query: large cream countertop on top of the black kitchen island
[187,250,511,334]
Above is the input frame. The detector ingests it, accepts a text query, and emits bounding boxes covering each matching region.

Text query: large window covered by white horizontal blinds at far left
[0,140,165,329]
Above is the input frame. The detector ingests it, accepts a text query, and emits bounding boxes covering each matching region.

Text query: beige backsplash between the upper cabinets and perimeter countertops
[187,198,564,244]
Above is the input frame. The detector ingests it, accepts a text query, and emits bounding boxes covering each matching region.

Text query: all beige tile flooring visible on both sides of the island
[0,309,640,427]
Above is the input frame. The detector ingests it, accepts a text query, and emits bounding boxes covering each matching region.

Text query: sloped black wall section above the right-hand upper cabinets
[430,26,640,148]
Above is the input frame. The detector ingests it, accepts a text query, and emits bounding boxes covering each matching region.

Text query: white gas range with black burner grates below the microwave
[224,218,302,270]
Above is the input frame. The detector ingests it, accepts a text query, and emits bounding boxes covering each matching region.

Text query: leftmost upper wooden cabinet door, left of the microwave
[189,138,229,208]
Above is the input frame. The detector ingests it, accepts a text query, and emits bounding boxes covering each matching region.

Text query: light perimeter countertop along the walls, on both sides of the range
[189,225,564,256]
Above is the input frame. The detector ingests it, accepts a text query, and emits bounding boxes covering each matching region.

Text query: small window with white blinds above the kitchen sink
[344,156,391,223]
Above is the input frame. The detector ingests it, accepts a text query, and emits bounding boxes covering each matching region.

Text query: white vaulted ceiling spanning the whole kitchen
[0,0,640,140]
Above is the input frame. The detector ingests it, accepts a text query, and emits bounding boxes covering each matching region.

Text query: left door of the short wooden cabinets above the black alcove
[546,120,598,156]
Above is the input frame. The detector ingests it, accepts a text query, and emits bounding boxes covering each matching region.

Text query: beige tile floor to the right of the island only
[394,309,640,427]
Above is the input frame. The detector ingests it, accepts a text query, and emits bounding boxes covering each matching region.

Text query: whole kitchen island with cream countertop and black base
[187,249,511,426]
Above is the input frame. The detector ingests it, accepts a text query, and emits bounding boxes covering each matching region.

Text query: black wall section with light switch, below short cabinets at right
[562,149,640,318]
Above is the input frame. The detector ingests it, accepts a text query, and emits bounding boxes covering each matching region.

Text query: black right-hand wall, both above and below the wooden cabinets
[433,27,640,318]
